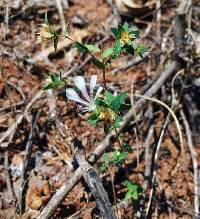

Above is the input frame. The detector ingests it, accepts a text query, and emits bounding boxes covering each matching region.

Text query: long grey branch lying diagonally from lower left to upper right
[38,62,179,219]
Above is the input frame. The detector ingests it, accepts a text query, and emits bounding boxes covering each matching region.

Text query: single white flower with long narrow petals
[66,75,103,112]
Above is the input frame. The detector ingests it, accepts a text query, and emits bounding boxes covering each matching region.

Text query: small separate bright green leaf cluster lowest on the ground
[124,180,143,201]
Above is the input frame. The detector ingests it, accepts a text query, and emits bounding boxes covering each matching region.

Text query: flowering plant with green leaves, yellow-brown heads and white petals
[38,14,149,207]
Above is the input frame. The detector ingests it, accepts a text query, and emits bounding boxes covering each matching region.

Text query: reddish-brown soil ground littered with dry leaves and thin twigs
[0,0,200,219]
